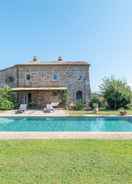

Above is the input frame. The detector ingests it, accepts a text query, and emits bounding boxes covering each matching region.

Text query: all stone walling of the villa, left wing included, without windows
[0,64,90,106]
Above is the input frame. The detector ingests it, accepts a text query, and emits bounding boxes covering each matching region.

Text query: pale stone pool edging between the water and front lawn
[0,132,132,140]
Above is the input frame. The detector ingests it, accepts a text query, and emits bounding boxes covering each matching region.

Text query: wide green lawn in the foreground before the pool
[0,140,132,184]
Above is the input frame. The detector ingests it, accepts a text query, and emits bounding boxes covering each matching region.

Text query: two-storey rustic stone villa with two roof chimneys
[0,57,90,108]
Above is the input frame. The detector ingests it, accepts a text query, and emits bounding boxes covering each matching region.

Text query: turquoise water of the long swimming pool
[0,117,132,132]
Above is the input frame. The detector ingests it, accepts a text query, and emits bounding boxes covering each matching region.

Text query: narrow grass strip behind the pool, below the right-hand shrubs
[66,110,132,116]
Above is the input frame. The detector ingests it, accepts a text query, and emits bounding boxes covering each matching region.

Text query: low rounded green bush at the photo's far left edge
[0,99,14,110]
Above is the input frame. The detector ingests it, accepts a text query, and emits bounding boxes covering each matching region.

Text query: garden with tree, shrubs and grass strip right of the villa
[69,77,132,115]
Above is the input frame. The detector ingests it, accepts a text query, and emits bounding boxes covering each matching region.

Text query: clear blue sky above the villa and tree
[0,0,132,91]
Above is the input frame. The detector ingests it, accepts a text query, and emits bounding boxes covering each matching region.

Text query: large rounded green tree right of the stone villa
[100,77,132,110]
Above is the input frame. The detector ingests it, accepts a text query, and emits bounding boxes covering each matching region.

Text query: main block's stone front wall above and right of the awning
[19,65,90,104]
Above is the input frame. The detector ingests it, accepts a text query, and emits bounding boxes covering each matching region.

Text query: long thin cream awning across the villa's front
[12,87,67,91]
